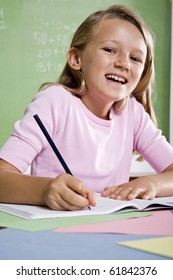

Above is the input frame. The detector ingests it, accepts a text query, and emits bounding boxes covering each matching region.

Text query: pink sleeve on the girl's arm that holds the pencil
[0,86,70,172]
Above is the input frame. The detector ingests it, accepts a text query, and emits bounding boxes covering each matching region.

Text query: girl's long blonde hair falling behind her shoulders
[40,5,157,125]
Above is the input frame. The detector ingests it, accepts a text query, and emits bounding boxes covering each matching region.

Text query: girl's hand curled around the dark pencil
[44,173,96,210]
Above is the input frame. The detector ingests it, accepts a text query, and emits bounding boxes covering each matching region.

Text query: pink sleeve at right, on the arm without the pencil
[132,100,173,173]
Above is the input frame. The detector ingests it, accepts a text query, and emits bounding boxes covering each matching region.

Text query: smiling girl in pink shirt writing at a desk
[0,5,173,210]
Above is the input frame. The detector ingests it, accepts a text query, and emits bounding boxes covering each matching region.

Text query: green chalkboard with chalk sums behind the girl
[0,0,171,146]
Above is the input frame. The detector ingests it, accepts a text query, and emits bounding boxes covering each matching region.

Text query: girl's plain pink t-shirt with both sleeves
[0,86,173,192]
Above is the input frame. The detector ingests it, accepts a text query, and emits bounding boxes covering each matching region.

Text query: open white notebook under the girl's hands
[0,194,173,219]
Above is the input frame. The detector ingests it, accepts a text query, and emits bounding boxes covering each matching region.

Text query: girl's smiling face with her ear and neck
[67,18,147,118]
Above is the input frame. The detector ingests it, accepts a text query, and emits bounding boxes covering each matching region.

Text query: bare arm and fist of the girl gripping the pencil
[0,159,95,210]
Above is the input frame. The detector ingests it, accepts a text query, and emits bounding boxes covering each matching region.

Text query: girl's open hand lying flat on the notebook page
[102,176,157,200]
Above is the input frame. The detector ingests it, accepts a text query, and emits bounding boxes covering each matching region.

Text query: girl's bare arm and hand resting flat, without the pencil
[102,164,173,200]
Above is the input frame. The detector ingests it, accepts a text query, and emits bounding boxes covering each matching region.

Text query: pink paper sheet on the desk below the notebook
[54,210,173,236]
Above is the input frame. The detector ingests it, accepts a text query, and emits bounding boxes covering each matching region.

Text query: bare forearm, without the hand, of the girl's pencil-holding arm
[0,170,51,205]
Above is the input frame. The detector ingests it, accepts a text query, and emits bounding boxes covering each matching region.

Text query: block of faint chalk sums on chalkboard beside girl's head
[33,16,76,73]
